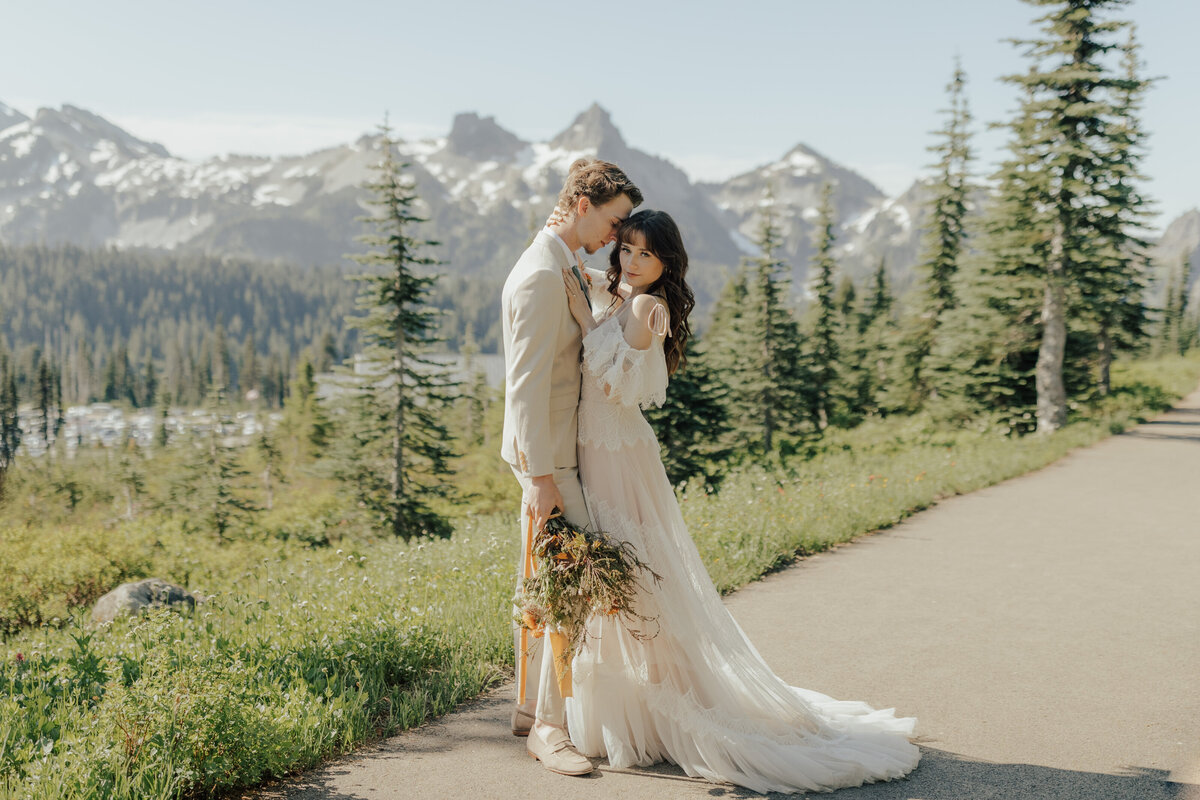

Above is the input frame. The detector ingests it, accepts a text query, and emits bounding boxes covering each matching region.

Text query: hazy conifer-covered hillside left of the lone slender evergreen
[0,245,354,405]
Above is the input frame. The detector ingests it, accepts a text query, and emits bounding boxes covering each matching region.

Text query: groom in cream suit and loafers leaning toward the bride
[500,158,642,775]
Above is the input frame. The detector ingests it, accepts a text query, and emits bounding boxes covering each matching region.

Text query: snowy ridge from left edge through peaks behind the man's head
[0,106,738,299]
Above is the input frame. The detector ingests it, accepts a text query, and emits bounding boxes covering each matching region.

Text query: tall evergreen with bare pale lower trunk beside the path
[1006,0,1130,432]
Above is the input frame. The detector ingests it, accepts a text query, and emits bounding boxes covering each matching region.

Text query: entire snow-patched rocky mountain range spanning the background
[0,95,1200,307]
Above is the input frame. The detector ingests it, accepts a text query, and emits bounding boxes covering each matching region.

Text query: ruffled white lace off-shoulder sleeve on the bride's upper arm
[583,315,667,408]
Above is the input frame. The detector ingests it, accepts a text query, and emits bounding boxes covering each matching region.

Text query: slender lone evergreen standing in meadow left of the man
[336,122,454,540]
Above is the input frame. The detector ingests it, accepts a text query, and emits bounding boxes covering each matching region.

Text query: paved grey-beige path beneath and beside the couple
[250,391,1200,800]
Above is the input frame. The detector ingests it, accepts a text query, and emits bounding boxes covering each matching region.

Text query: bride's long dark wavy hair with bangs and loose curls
[607,209,696,374]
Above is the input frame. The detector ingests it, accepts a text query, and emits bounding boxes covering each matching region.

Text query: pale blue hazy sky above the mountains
[0,0,1200,225]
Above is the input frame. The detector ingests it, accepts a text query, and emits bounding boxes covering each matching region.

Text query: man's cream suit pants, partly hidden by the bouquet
[512,467,590,726]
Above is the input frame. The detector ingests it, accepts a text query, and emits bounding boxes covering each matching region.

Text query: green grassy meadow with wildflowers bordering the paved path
[0,357,1200,800]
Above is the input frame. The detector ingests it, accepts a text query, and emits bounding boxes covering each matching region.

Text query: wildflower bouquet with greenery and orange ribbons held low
[514,510,662,702]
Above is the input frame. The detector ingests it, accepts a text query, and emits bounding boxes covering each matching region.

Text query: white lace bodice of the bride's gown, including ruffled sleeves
[580,302,667,450]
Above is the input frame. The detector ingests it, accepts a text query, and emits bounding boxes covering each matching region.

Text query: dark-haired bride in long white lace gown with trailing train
[564,211,920,793]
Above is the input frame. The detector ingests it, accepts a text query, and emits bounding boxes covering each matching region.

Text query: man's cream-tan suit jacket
[500,230,583,477]
